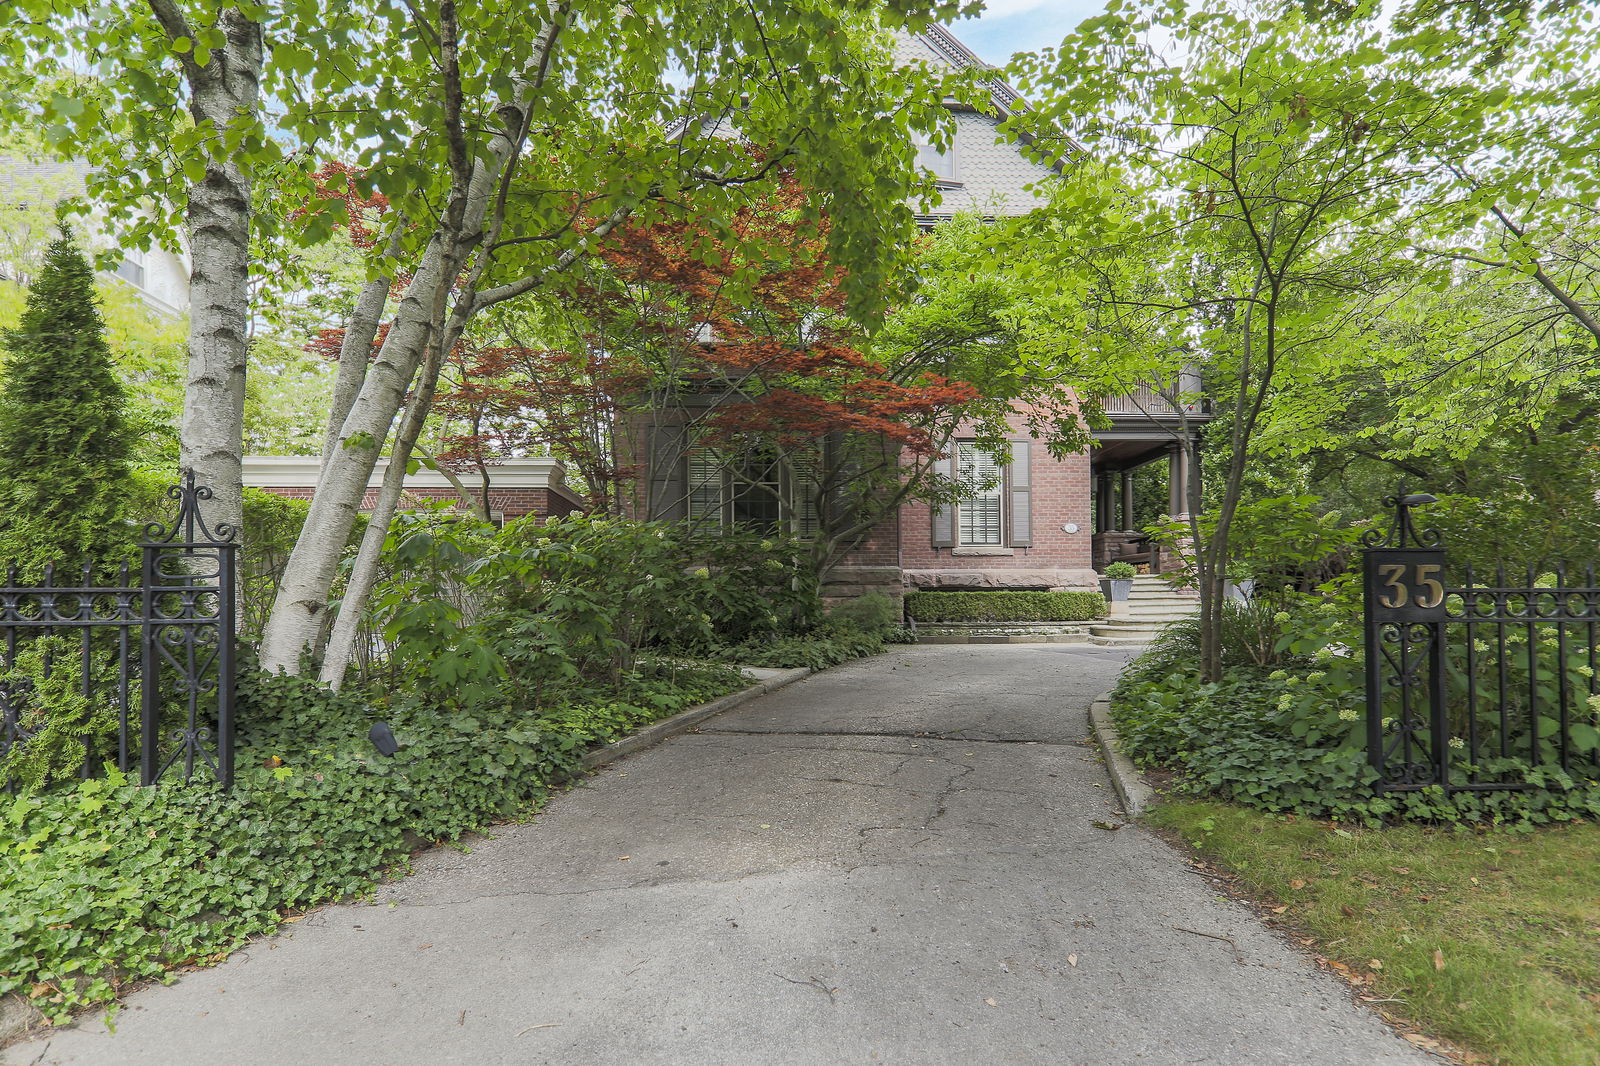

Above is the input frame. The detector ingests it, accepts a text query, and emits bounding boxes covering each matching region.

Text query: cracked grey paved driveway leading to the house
[9,645,1434,1066]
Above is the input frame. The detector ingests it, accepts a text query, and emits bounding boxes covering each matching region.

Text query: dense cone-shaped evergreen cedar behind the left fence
[0,234,138,569]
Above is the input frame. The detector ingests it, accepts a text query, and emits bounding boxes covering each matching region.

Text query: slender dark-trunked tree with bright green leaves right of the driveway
[1024,3,1453,679]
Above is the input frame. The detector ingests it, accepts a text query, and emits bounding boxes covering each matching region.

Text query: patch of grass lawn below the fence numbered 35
[1149,800,1600,1066]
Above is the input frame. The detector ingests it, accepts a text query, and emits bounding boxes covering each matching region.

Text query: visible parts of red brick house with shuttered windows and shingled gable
[634,26,1206,600]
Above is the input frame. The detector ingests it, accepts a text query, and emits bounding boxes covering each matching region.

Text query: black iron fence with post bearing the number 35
[1363,491,1600,792]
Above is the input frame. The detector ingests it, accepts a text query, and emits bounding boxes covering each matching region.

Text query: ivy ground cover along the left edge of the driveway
[0,664,746,1021]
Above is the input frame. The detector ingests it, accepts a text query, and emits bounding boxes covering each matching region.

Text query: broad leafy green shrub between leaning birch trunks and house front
[371,512,821,707]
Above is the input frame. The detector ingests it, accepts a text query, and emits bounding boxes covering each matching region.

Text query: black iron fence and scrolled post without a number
[0,472,238,791]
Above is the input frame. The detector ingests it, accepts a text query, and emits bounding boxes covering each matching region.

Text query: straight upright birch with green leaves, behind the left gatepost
[0,0,267,541]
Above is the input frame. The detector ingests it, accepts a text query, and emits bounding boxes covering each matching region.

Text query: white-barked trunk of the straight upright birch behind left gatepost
[150,0,262,535]
